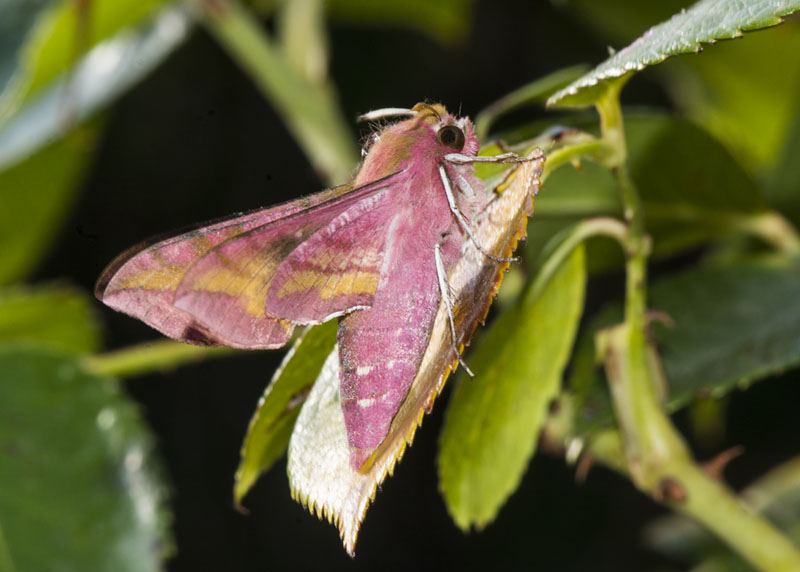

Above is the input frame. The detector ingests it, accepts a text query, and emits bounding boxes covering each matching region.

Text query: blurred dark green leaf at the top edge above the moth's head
[327,0,472,43]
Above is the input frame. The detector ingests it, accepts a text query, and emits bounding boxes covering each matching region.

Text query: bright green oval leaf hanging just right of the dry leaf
[439,246,586,530]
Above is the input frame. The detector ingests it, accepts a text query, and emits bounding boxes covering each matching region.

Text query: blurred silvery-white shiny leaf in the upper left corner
[0,7,190,170]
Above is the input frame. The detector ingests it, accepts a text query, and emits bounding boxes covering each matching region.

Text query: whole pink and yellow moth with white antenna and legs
[95,103,539,472]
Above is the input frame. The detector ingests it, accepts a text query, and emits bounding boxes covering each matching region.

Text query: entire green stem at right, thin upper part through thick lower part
[597,88,800,572]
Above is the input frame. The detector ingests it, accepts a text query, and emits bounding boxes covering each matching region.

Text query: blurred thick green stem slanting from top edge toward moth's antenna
[196,0,358,184]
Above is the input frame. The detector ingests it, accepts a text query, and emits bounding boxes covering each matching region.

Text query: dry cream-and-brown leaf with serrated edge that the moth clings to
[288,150,543,555]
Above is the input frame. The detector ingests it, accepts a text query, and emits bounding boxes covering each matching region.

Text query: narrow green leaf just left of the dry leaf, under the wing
[233,320,337,504]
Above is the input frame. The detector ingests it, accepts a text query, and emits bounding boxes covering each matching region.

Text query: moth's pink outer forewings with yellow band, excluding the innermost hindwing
[95,173,397,349]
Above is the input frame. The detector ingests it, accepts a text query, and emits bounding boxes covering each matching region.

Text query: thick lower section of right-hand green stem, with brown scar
[603,324,800,572]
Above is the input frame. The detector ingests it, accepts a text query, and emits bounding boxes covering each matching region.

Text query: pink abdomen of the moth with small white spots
[338,198,462,470]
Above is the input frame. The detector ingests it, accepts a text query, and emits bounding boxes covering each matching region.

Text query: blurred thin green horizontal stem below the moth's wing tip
[82,340,238,377]
